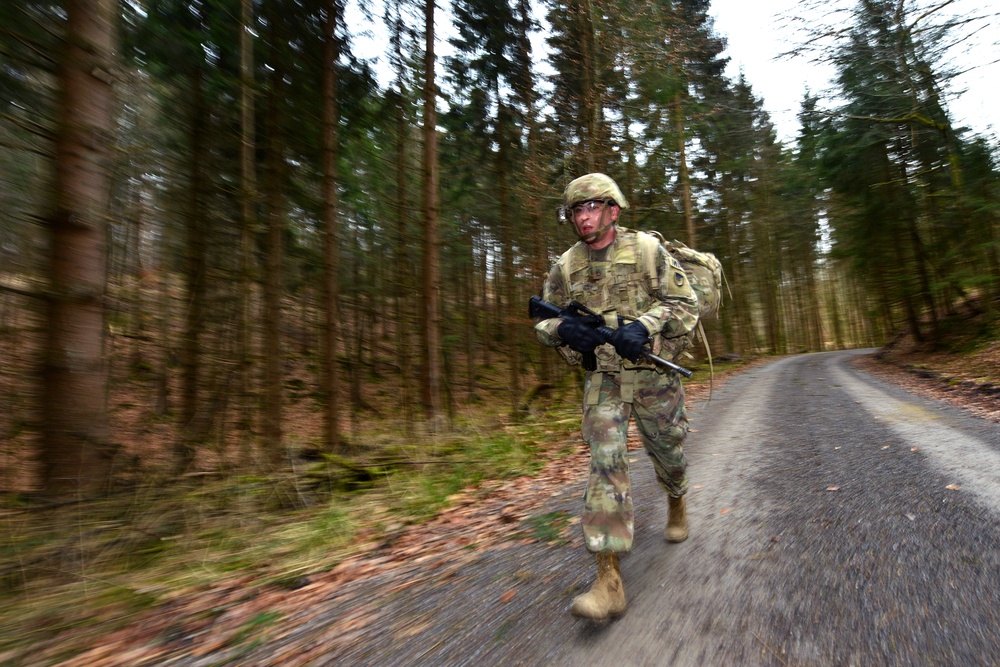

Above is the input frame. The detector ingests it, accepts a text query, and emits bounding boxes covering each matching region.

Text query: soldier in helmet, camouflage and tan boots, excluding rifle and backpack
[535,173,698,620]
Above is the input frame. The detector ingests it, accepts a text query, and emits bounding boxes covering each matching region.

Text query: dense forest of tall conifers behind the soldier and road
[0,0,1000,656]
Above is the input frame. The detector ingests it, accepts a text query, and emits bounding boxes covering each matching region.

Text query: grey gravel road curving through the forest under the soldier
[192,351,1000,667]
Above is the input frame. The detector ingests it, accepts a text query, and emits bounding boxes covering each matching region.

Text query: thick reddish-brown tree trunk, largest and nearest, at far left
[41,0,117,496]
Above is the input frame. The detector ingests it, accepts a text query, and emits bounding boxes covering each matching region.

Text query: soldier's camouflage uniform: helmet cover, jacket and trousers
[535,174,698,553]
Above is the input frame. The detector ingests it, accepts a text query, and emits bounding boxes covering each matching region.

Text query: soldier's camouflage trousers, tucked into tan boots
[581,370,688,553]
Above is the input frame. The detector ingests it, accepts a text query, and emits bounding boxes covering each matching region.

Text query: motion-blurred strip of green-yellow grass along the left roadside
[0,406,579,664]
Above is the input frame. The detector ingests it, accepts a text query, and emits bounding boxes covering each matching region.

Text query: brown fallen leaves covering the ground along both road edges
[0,339,1000,667]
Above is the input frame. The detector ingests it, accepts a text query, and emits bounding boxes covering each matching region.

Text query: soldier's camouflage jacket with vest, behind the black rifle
[535,226,698,371]
